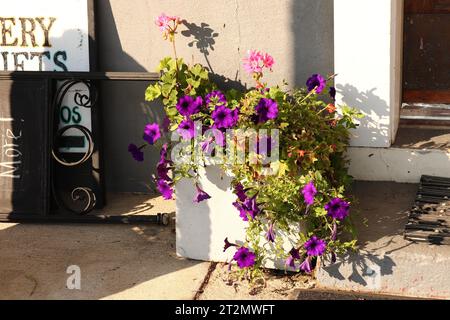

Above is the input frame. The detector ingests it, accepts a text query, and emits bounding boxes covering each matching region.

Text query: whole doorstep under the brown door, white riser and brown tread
[347,125,450,183]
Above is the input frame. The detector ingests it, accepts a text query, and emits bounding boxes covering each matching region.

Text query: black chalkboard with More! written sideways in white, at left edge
[0,79,50,214]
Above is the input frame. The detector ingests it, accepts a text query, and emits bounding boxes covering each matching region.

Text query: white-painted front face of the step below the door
[348,147,450,183]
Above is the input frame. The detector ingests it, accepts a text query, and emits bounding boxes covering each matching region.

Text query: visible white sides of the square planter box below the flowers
[176,166,298,270]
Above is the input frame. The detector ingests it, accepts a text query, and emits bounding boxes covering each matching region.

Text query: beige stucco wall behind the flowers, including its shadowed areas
[97,0,334,191]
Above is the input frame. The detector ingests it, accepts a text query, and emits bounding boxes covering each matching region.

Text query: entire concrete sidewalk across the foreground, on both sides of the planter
[0,182,450,300]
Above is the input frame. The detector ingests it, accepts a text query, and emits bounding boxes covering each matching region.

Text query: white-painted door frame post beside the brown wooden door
[334,0,403,147]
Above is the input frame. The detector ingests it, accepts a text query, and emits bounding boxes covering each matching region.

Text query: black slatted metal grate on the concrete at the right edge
[405,176,450,245]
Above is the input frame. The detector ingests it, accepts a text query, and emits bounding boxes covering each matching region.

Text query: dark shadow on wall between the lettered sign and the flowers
[96,1,164,193]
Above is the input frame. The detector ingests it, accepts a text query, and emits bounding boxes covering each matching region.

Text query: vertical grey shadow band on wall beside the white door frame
[292,0,334,86]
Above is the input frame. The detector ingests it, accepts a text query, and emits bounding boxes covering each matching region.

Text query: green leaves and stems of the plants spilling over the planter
[145,53,362,278]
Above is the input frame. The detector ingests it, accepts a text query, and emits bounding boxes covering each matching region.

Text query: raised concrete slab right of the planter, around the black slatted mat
[316,181,450,299]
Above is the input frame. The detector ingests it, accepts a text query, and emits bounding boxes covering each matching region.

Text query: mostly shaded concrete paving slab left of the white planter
[0,195,209,300]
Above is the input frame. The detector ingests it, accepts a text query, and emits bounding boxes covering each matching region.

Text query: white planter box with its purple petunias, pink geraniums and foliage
[129,14,361,278]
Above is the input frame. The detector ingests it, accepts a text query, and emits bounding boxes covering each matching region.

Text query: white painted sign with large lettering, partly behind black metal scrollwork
[0,0,92,152]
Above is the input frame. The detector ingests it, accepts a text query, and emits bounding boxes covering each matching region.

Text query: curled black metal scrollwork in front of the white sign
[52,80,98,214]
